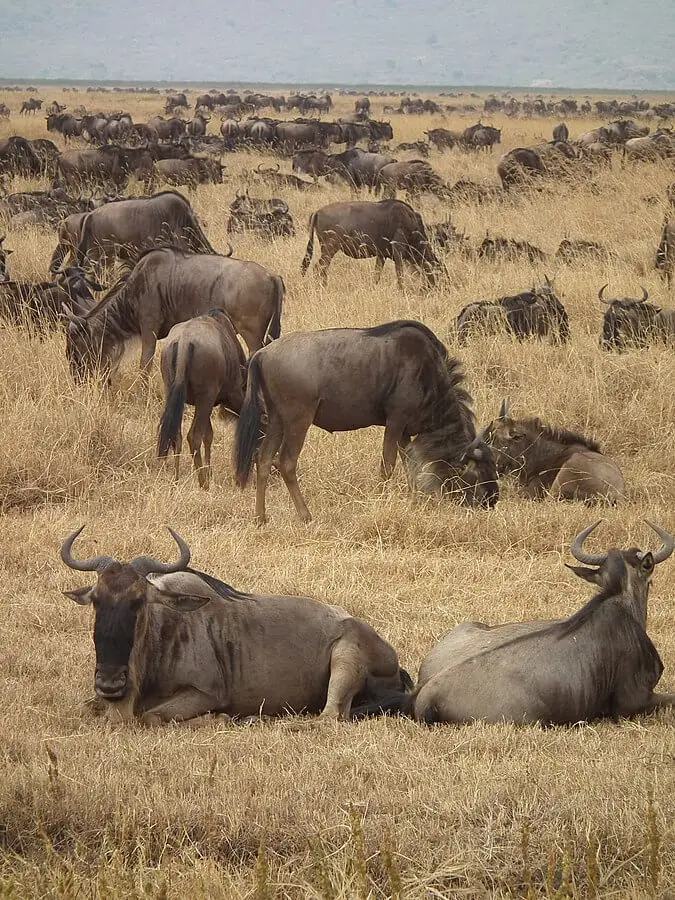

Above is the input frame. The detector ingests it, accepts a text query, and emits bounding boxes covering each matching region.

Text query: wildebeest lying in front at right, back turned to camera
[354,520,675,725]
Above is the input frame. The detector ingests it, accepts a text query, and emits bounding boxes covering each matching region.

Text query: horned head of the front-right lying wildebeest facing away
[566,519,675,628]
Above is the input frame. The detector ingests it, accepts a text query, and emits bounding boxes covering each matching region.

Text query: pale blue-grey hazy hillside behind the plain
[0,0,675,90]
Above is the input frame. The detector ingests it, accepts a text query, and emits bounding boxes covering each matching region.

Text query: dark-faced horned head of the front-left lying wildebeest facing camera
[61,525,193,700]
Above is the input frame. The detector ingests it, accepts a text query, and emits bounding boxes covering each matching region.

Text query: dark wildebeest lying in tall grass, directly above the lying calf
[457,278,570,344]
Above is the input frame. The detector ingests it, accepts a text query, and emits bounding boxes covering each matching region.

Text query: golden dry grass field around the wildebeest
[0,89,675,898]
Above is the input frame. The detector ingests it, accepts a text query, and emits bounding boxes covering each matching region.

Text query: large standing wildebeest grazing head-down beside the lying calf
[235,321,499,523]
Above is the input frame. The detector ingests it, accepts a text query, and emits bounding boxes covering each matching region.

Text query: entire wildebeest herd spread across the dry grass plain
[0,82,675,724]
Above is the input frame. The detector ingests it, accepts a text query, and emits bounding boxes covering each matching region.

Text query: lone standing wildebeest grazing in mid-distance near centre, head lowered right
[301,200,443,287]
